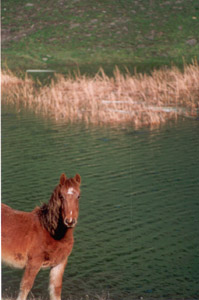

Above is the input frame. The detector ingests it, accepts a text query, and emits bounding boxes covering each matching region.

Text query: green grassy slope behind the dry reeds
[2,0,199,74]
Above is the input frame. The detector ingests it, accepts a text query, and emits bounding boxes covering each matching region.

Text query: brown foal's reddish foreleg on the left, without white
[17,262,40,300]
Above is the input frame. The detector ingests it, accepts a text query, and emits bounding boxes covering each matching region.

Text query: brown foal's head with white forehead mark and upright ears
[59,174,81,228]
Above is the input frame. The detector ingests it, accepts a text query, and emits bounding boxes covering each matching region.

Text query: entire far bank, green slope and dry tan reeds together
[2,0,199,127]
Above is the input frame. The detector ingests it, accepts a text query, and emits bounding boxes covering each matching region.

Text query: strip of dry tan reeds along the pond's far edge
[1,63,199,128]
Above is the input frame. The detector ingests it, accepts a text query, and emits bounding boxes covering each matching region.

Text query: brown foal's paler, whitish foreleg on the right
[49,262,67,300]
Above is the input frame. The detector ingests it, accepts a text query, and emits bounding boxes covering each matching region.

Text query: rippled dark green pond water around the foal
[1,104,199,300]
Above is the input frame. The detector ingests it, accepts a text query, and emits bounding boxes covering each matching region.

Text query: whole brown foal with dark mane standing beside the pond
[1,174,81,300]
